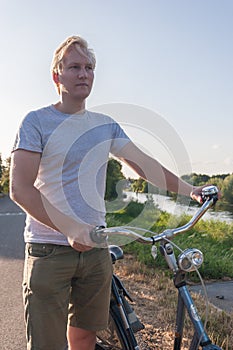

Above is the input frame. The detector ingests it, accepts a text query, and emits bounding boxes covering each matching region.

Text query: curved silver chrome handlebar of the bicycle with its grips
[90,186,218,245]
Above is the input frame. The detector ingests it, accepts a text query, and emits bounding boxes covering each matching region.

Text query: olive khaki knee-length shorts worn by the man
[23,243,112,350]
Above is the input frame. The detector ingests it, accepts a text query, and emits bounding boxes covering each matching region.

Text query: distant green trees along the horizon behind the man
[0,154,233,205]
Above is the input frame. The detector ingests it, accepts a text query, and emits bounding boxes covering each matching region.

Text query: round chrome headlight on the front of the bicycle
[178,248,204,272]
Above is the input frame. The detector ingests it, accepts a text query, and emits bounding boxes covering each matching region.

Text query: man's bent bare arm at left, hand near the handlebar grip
[10,149,93,251]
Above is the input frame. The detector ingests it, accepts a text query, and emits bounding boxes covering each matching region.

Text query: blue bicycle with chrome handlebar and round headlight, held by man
[91,186,221,350]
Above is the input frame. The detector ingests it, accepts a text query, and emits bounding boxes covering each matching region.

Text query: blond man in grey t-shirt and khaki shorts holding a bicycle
[10,36,208,350]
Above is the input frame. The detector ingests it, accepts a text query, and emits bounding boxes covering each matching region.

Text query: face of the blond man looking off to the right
[58,48,94,101]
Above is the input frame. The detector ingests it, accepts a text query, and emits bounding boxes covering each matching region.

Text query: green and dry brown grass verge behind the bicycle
[107,200,233,350]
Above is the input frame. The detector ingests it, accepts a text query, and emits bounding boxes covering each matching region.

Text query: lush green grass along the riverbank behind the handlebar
[107,198,233,280]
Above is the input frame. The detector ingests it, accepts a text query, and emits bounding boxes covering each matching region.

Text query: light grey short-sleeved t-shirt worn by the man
[13,105,130,245]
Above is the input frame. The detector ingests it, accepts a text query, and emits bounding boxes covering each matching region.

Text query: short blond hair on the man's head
[51,35,96,74]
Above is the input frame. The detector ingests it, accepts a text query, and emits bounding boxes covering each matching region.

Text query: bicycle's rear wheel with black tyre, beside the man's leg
[96,305,133,350]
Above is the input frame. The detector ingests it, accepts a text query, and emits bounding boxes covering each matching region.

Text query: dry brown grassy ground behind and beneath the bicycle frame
[115,255,233,350]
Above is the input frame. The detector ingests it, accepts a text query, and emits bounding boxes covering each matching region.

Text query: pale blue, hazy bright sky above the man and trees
[0,0,233,175]
